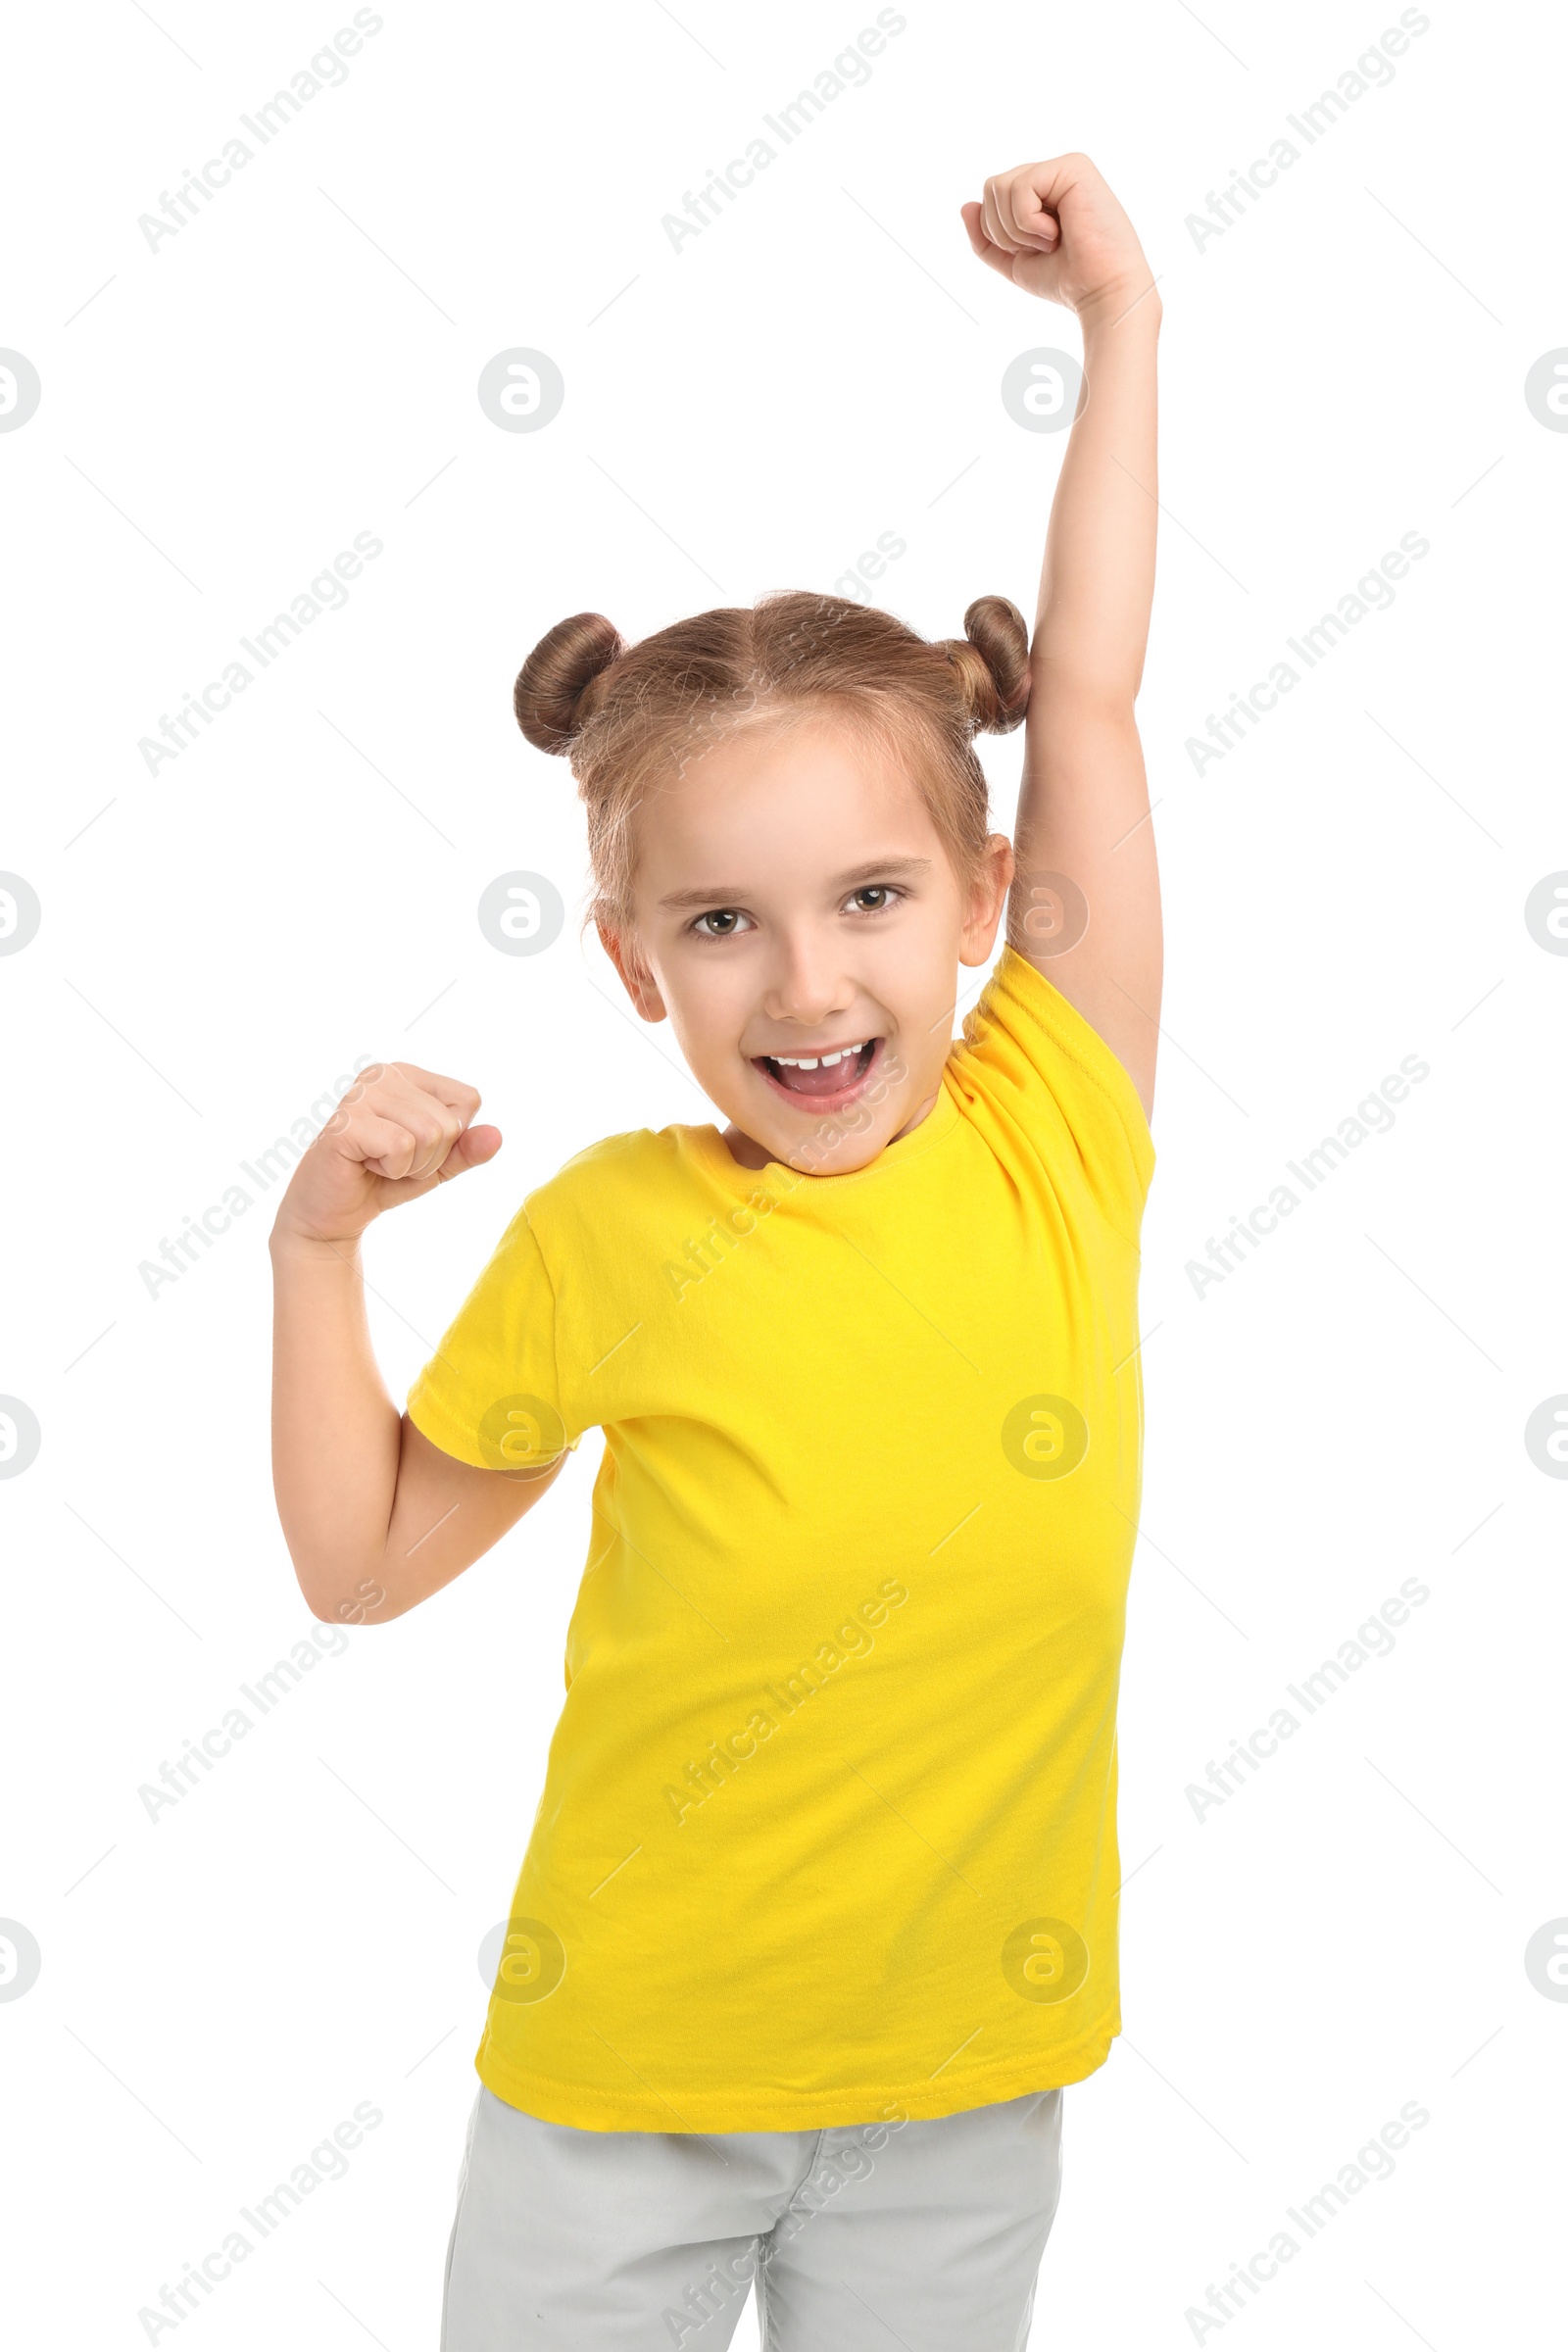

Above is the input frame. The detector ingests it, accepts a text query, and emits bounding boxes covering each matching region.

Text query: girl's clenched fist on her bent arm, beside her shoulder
[272,1060,501,1245]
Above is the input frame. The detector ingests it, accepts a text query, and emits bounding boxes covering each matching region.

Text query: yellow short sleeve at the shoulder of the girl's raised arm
[950,946,1154,1225]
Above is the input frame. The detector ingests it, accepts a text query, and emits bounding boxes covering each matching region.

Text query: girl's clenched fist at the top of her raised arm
[961,155,1152,318]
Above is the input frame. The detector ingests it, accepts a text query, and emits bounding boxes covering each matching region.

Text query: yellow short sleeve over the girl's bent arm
[409,1209,581,1475]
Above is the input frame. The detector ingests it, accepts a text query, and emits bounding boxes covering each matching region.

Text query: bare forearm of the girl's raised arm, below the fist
[1030,287,1161,715]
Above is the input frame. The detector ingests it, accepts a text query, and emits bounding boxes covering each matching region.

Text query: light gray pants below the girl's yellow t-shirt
[442,2088,1062,2352]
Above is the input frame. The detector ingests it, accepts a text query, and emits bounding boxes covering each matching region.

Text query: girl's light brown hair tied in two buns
[513,590,1030,936]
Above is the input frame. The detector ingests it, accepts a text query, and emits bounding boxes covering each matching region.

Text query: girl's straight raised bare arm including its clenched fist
[964,155,1163,1112]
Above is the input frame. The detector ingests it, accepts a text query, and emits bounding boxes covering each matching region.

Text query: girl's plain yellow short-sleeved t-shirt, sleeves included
[409,948,1154,2131]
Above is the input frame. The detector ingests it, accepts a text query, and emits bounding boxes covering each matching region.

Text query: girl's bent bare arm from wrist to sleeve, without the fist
[272,1233,564,1625]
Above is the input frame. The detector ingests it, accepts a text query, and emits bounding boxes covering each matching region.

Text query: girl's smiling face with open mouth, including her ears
[604,717,1013,1176]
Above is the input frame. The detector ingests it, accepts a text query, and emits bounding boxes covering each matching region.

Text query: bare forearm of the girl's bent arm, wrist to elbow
[272,1233,402,1616]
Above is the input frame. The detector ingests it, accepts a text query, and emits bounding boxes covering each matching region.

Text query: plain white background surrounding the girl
[0,0,1568,2352]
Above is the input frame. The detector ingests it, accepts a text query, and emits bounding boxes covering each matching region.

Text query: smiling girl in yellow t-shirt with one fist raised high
[272,155,1159,2352]
